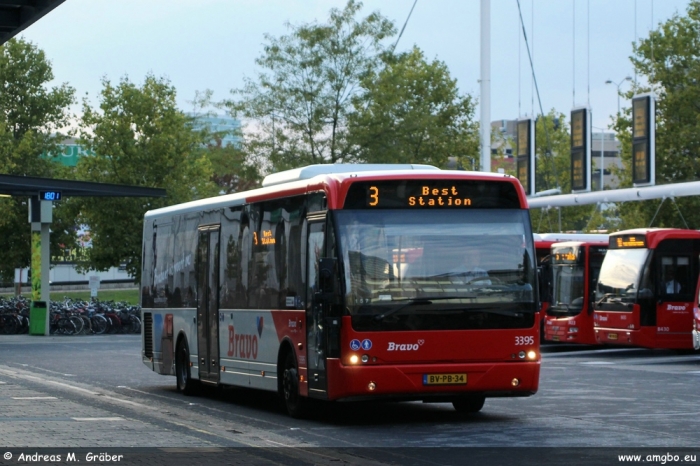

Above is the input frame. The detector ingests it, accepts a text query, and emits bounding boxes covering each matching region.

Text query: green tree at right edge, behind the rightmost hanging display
[614,0,700,228]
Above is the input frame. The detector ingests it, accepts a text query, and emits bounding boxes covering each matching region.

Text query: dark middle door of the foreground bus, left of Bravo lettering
[197,225,219,383]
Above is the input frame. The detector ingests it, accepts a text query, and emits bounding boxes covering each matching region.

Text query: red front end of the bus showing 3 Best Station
[302,177,540,410]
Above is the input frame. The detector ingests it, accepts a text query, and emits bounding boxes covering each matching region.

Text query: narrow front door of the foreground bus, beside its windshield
[306,216,327,397]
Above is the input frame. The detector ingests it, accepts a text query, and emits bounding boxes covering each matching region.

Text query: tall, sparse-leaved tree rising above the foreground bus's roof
[224,0,395,171]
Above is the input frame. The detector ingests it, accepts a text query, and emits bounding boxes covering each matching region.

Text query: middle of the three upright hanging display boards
[571,108,591,193]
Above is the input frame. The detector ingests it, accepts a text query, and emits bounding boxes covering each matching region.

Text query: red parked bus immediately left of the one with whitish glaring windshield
[543,239,608,345]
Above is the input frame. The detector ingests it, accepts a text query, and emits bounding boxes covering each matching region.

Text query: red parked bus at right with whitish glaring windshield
[593,228,700,349]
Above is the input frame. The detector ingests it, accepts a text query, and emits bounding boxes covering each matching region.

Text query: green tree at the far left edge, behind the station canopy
[0,39,75,280]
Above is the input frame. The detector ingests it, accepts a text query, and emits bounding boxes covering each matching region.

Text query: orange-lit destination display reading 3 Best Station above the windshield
[344,179,520,209]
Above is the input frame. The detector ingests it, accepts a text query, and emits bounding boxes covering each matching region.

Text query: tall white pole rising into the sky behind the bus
[480,0,491,172]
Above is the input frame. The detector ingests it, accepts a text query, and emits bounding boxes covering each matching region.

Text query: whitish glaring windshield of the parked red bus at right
[596,249,649,302]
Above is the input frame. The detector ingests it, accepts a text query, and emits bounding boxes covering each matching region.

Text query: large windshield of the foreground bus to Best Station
[335,209,536,330]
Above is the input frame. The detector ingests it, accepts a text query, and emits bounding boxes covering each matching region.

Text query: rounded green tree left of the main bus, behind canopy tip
[71,75,217,280]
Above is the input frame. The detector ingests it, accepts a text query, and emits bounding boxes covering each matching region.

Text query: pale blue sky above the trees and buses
[18,0,689,132]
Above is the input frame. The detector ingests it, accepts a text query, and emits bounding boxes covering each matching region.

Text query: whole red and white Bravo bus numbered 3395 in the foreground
[141,165,540,417]
